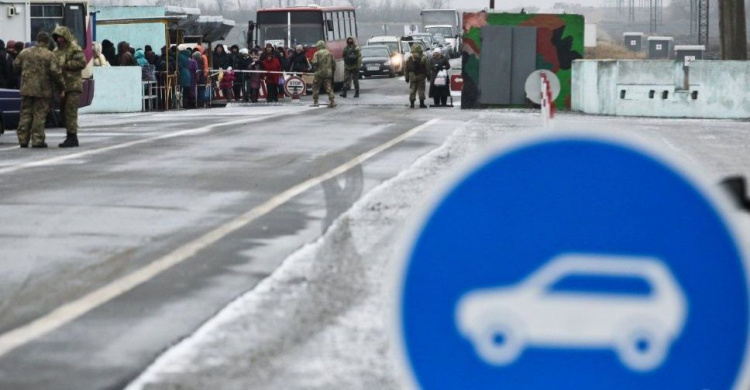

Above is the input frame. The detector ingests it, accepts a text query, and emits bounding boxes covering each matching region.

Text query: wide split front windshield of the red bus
[258,11,325,47]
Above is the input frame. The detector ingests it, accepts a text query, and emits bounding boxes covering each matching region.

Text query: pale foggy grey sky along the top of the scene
[92,0,750,50]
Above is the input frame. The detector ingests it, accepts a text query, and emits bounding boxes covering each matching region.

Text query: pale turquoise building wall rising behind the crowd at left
[91,6,166,54]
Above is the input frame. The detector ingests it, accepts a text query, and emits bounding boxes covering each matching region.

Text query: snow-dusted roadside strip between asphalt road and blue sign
[128,113,539,390]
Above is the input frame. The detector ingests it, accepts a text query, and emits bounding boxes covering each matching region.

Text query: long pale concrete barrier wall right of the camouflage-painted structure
[571,60,750,119]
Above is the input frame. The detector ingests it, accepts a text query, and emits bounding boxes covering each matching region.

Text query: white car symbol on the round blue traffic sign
[456,254,687,372]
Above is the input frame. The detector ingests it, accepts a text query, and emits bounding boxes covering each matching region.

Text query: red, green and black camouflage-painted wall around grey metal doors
[461,12,585,109]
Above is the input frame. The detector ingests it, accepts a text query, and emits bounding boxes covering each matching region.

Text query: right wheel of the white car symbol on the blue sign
[616,327,669,372]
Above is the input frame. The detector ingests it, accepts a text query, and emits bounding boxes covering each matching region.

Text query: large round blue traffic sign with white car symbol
[395,134,750,390]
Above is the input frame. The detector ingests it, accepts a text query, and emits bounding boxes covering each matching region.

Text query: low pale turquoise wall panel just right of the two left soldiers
[79,66,143,114]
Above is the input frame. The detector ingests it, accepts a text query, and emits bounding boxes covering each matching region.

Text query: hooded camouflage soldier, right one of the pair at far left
[52,26,86,148]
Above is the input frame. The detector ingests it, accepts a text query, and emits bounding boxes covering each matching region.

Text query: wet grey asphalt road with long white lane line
[0,74,464,389]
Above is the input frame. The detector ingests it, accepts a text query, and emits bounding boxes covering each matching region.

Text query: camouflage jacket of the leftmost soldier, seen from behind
[13,45,65,98]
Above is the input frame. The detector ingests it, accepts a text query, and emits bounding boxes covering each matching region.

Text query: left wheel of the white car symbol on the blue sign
[474,322,524,366]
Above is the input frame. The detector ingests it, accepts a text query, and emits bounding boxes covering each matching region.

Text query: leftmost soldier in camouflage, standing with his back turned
[13,32,65,148]
